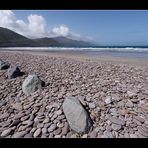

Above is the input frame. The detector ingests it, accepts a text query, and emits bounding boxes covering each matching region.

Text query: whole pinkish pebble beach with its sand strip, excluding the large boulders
[0,51,148,138]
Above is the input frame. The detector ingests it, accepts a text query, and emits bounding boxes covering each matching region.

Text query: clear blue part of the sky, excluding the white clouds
[1,10,148,45]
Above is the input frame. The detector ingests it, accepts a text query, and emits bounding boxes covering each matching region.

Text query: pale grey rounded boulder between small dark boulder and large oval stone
[22,75,44,95]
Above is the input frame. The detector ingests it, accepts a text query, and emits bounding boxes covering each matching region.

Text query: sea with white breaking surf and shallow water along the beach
[0,46,148,60]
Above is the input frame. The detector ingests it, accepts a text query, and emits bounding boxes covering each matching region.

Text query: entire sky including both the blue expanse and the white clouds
[0,10,148,46]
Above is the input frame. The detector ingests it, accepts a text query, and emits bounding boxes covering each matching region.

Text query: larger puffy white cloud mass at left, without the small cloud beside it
[0,10,47,38]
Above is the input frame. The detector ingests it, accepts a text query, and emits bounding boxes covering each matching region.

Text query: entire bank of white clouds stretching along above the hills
[0,10,91,40]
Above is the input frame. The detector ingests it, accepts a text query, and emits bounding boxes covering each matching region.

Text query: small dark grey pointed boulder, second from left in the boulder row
[7,65,21,79]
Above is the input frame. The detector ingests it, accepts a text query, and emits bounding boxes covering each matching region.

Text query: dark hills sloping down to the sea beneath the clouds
[0,27,93,47]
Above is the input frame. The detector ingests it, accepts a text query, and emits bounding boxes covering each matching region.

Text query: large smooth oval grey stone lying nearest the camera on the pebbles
[63,97,92,133]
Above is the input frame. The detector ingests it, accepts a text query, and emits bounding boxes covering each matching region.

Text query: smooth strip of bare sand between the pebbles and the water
[0,50,148,67]
